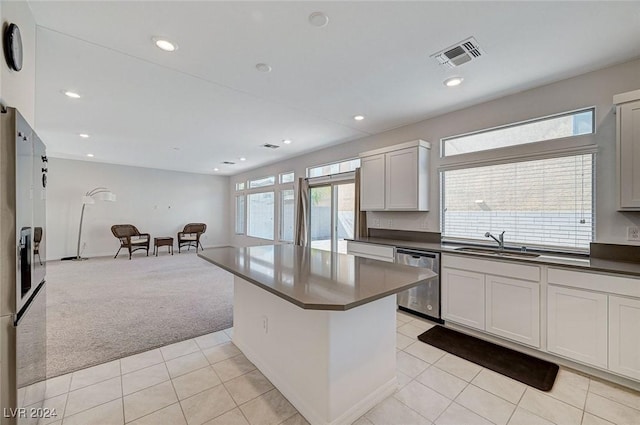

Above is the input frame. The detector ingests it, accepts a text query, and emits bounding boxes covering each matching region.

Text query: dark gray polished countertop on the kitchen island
[198,245,437,310]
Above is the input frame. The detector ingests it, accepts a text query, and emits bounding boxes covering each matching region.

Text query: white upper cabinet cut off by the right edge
[613,90,640,211]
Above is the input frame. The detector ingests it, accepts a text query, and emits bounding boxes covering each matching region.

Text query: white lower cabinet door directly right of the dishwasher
[441,268,485,330]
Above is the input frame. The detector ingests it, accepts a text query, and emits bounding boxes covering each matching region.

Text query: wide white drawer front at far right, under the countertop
[547,267,640,298]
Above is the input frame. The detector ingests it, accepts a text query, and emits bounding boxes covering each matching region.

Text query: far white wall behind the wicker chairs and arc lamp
[47,158,229,260]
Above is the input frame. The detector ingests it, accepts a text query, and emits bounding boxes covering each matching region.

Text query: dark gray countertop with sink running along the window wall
[354,238,640,277]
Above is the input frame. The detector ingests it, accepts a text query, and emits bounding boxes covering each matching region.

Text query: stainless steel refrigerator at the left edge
[0,108,48,425]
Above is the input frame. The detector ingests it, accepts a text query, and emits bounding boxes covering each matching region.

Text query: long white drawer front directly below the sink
[442,254,540,282]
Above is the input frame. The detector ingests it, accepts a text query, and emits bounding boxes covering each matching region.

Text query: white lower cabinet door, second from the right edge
[547,285,608,368]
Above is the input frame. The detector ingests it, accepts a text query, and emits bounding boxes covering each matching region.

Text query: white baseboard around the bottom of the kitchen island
[233,335,398,425]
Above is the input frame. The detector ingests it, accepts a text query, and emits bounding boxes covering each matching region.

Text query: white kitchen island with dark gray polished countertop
[199,245,436,425]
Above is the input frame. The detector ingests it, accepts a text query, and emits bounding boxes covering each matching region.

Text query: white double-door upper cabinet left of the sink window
[360,140,431,211]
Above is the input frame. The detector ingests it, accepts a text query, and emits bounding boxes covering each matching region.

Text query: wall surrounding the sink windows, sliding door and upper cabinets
[230,60,640,246]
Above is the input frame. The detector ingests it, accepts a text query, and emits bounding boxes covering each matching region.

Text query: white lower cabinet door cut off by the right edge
[609,295,640,380]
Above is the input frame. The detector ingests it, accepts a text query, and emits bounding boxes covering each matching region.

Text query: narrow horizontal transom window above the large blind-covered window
[441,108,595,157]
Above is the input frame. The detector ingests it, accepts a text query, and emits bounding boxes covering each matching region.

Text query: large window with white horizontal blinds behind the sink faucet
[441,154,595,250]
